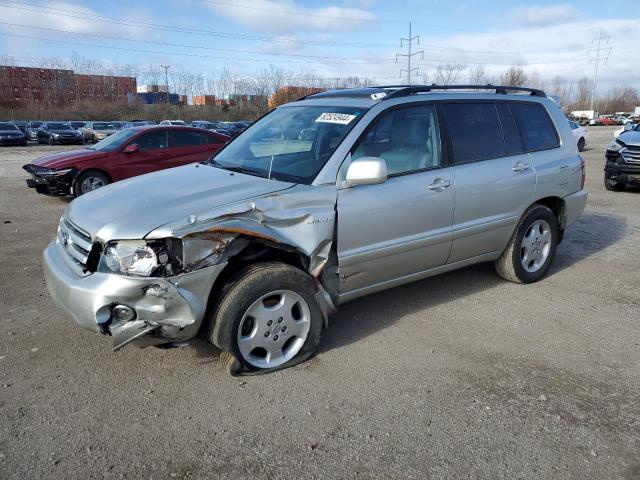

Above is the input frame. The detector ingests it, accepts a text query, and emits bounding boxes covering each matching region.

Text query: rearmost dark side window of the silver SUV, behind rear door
[510,102,560,152]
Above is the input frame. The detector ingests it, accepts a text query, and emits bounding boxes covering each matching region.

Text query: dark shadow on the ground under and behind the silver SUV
[320,213,627,351]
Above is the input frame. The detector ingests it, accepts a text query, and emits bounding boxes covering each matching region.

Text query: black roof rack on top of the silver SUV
[295,83,547,102]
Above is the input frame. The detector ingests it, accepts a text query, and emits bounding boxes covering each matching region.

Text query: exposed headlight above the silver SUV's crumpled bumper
[98,239,181,277]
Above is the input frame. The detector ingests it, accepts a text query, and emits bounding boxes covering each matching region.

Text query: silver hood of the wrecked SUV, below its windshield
[66,164,294,241]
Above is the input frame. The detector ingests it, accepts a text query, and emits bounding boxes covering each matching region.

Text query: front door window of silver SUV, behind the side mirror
[352,105,442,175]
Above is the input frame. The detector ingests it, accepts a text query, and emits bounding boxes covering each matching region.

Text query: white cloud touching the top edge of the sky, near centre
[208,0,375,32]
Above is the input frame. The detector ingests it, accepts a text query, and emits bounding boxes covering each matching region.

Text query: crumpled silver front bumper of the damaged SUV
[43,241,226,350]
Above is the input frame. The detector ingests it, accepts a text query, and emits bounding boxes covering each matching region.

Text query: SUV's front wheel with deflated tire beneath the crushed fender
[207,262,324,375]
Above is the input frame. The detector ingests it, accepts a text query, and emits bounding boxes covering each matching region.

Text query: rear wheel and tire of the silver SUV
[495,204,560,283]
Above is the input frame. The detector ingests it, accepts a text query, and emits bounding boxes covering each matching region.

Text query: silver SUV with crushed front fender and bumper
[44,85,587,374]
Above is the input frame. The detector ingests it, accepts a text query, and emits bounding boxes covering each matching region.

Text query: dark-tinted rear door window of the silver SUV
[442,103,506,164]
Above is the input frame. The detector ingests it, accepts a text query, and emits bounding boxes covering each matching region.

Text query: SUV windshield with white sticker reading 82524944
[211,106,365,184]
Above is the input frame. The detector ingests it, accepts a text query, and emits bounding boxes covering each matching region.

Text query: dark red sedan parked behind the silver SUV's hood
[22,125,229,196]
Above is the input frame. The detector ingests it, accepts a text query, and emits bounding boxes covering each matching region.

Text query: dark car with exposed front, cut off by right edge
[604,123,640,192]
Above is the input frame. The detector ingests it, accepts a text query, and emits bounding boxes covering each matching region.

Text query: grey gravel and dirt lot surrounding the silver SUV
[0,127,640,479]
